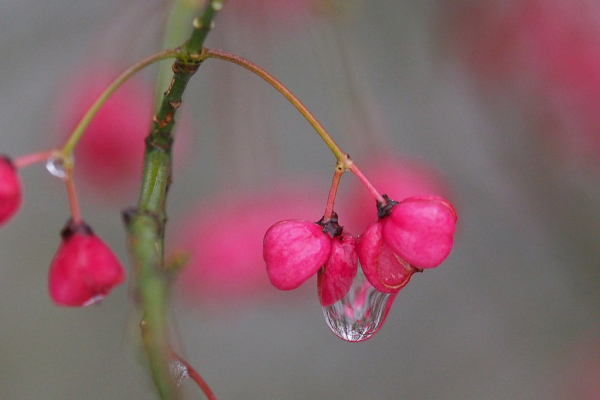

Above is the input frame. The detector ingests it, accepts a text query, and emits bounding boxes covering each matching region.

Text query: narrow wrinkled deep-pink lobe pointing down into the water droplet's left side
[317,232,358,307]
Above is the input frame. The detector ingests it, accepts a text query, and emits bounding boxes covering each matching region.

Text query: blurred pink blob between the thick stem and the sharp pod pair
[172,184,325,302]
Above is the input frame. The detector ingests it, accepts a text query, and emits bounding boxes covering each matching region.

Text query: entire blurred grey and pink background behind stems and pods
[0,0,600,400]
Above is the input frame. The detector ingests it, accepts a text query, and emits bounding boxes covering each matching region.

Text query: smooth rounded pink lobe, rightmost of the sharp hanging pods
[381,196,456,268]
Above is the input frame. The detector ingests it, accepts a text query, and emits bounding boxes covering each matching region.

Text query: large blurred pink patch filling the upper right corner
[448,0,600,161]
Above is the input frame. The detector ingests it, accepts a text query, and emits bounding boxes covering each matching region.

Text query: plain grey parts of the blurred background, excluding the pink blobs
[0,0,600,400]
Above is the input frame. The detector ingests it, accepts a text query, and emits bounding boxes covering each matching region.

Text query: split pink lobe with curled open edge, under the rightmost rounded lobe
[356,221,418,293]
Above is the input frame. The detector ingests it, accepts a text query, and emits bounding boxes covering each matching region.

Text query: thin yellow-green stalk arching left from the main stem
[60,49,181,158]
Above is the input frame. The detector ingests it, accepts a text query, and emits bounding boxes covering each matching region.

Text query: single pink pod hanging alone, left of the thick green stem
[48,221,125,307]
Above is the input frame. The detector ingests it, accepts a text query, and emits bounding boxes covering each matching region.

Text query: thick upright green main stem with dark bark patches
[125,0,223,400]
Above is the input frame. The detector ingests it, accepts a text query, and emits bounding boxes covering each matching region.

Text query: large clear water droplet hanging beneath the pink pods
[323,269,396,342]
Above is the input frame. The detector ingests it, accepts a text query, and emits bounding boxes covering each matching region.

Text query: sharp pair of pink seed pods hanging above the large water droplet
[263,192,456,307]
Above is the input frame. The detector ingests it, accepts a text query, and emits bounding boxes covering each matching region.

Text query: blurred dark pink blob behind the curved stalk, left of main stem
[57,67,185,200]
